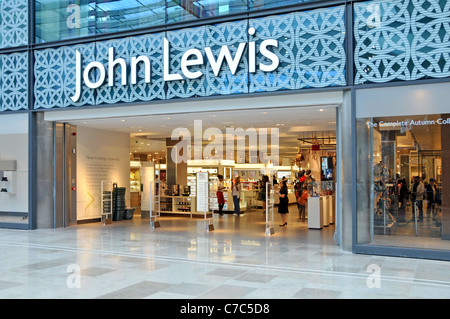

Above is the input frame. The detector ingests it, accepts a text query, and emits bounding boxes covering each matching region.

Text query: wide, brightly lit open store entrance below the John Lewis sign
[66,106,338,241]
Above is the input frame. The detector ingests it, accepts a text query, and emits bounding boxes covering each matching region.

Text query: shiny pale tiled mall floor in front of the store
[0,207,450,300]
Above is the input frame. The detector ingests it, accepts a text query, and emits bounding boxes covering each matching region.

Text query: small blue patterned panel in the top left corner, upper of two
[0,0,28,48]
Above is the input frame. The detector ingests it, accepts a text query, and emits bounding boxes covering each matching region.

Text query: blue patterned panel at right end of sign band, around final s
[250,6,345,92]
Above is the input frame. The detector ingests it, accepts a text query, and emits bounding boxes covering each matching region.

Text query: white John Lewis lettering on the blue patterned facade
[70,28,280,102]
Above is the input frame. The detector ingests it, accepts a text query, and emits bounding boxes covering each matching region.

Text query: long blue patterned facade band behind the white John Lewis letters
[34,6,346,109]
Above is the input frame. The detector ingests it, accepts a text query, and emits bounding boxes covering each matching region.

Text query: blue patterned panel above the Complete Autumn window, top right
[354,0,450,84]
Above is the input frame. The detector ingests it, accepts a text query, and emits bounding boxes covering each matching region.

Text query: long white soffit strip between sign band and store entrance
[44,91,343,122]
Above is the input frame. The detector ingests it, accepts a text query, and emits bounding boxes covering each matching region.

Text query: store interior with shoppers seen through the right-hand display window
[365,114,450,248]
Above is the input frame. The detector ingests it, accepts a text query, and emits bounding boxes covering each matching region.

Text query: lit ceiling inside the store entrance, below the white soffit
[69,106,336,157]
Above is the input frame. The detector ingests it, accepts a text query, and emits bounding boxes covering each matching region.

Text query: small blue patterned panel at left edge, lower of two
[0,52,28,111]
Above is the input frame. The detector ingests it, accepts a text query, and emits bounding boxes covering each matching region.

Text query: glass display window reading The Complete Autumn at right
[357,114,450,250]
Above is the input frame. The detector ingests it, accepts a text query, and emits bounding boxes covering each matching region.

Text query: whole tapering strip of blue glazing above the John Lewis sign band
[35,0,332,43]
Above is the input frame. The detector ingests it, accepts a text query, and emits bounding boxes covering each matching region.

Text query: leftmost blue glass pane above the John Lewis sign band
[36,0,165,43]
